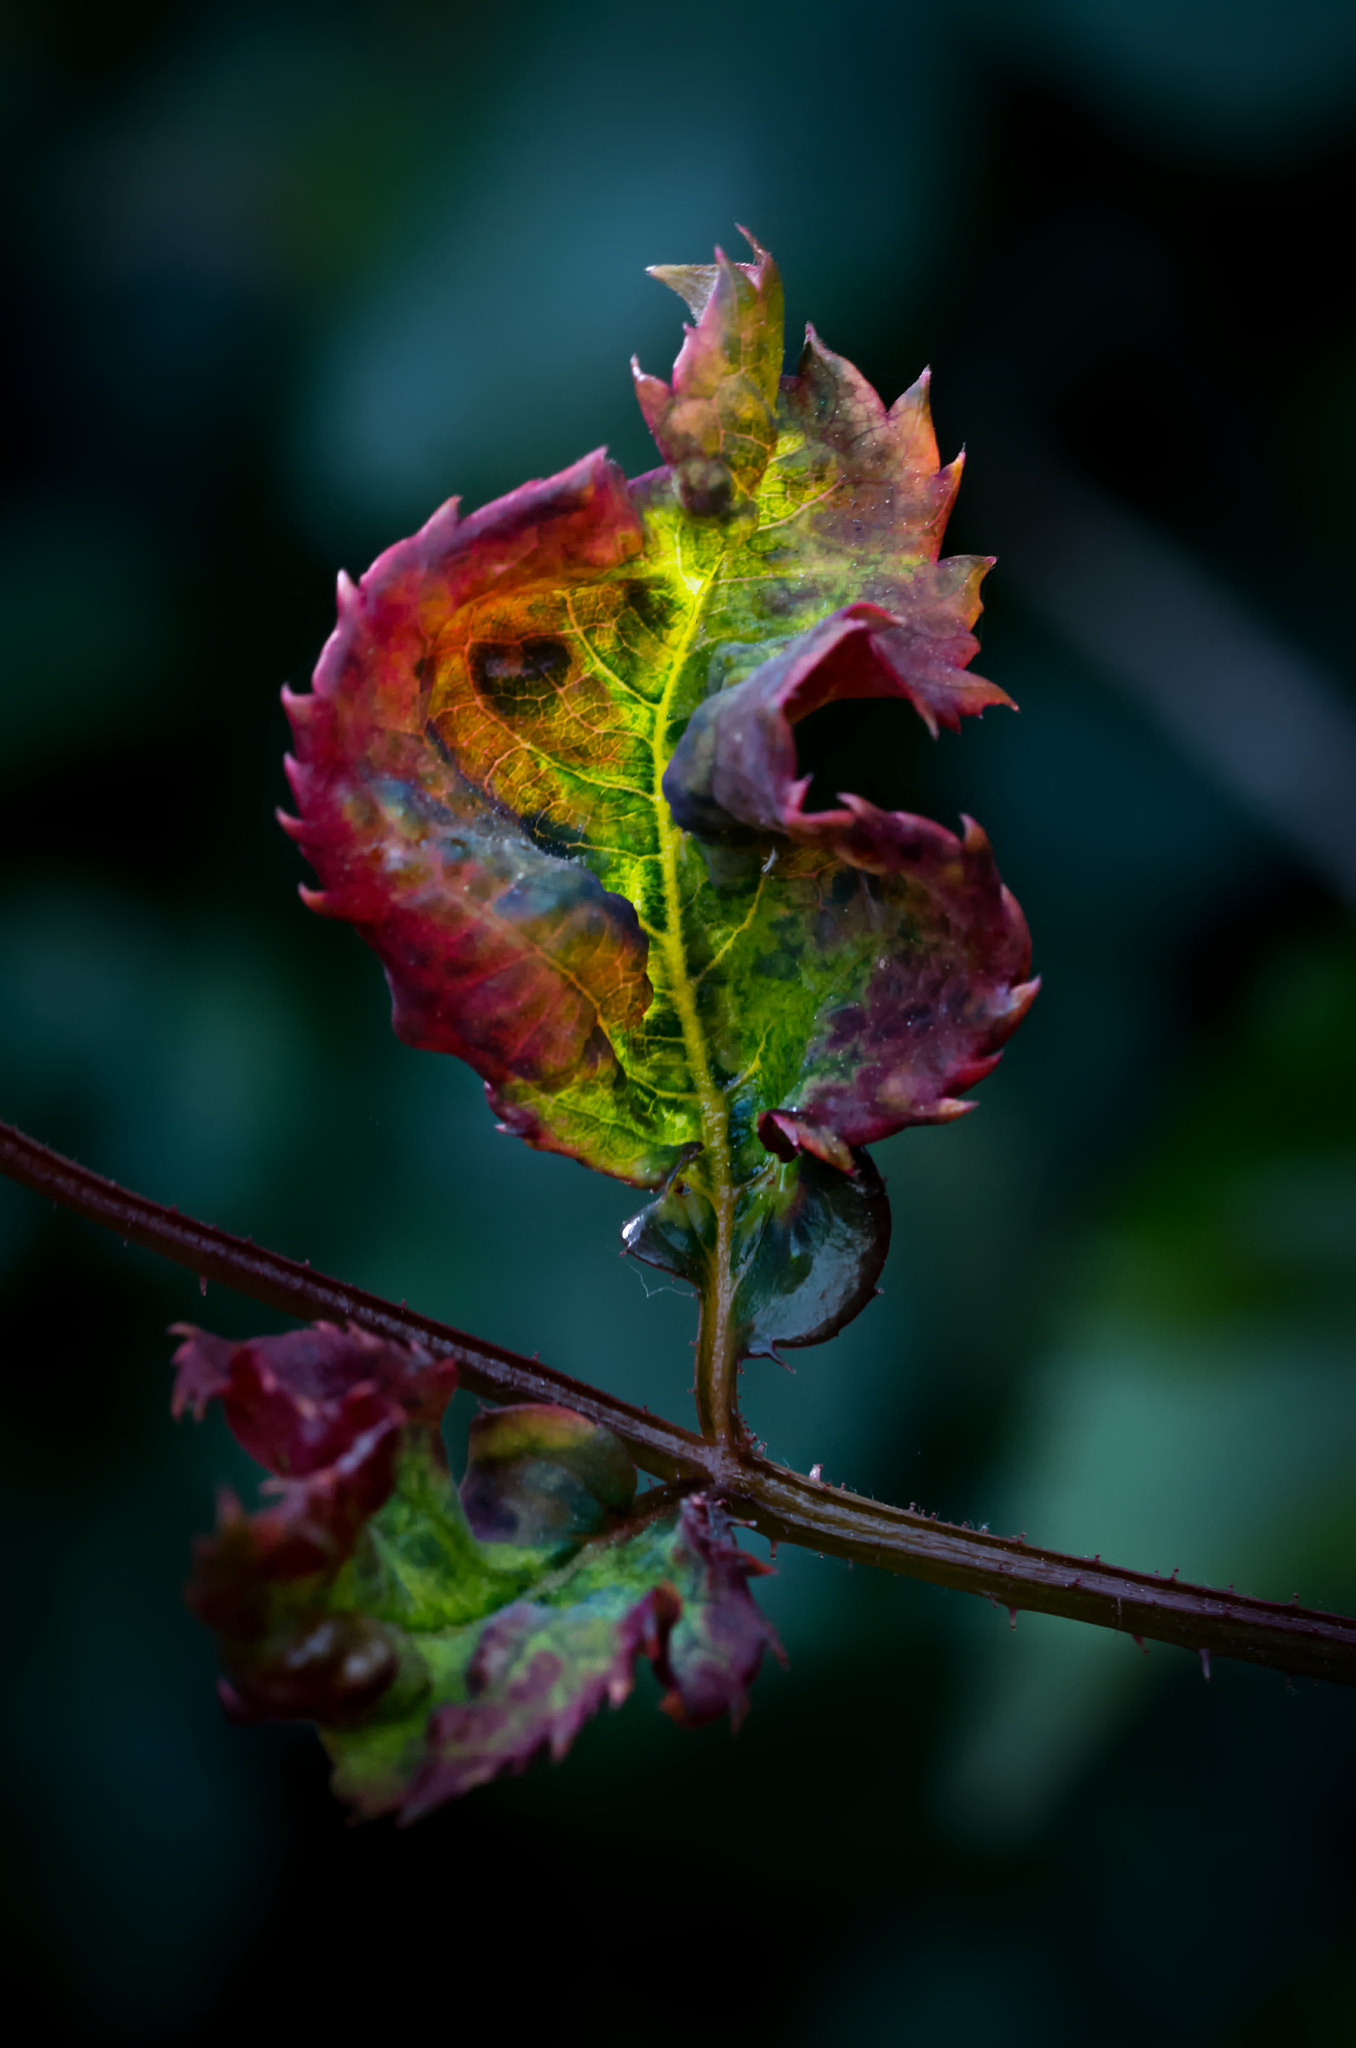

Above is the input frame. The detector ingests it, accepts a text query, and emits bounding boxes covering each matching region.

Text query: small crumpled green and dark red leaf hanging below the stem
[174,1323,780,1821]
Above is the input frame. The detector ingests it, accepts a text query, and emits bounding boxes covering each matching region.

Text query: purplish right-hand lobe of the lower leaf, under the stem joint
[653,1493,787,1729]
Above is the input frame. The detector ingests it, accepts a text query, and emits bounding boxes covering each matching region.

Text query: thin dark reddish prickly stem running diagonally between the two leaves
[0,1124,1356,1686]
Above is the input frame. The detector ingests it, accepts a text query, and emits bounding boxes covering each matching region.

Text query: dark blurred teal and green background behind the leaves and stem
[0,0,1356,2048]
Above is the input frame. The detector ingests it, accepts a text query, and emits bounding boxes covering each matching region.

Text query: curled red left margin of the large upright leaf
[283,451,651,1087]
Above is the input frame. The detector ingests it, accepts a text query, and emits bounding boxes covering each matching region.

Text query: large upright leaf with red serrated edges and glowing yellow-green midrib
[287,238,1034,1341]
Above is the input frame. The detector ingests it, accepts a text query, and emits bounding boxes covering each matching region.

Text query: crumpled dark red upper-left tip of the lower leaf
[172,1323,457,1572]
